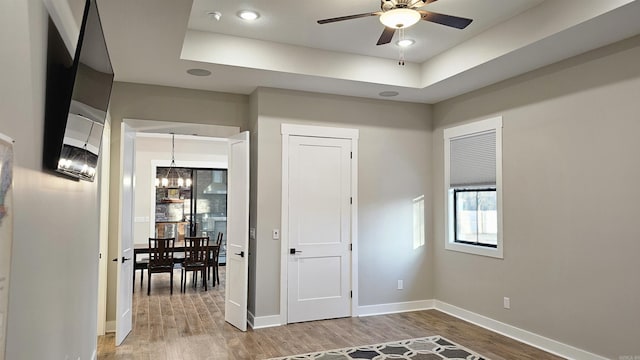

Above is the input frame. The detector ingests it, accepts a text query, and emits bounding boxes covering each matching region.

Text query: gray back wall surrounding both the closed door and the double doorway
[107,83,433,320]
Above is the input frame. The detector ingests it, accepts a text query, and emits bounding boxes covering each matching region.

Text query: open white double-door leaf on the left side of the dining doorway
[113,123,135,346]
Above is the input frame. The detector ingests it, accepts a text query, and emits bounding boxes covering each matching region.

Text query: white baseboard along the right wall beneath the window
[433,300,607,360]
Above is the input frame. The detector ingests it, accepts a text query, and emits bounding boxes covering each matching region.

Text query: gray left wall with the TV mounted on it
[0,0,99,359]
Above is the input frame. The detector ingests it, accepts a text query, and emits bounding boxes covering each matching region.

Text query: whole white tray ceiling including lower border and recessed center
[98,0,640,103]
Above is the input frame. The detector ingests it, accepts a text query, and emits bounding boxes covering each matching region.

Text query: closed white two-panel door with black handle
[287,136,352,323]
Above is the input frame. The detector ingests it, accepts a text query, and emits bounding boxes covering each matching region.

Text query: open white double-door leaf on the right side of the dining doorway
[224,131,249,331]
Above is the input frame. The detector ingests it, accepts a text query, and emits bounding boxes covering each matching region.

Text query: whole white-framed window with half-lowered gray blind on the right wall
[444,118,503,258]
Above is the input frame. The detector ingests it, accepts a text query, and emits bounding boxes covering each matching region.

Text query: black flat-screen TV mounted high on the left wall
[43,0,113,181]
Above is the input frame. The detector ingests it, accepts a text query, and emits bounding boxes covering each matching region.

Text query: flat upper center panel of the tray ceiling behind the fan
[189,0,542,62]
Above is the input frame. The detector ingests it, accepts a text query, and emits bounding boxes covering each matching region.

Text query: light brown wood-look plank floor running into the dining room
[98,267,562,360]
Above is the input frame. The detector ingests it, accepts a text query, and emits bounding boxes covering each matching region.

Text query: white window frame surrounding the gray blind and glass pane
[444,117,504,259]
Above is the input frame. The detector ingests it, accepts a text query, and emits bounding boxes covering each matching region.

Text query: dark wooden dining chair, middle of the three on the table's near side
[180,236,209,292]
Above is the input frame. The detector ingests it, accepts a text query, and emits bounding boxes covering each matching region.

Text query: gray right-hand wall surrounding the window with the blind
[433,37,640,359]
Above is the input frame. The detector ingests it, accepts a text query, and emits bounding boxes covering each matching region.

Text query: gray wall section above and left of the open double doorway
[107,82,249,321]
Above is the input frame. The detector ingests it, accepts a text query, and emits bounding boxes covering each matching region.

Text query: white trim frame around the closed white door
[280,124,359,324]
